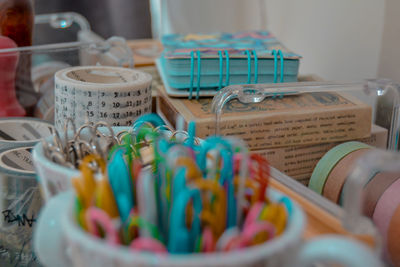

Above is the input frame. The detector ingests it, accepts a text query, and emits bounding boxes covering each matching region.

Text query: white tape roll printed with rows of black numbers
[55,66,152,131]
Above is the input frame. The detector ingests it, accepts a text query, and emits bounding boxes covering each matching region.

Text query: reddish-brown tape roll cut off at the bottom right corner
[386,205,400,267]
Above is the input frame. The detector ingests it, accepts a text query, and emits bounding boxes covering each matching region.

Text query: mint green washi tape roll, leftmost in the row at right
[308,141,371,195]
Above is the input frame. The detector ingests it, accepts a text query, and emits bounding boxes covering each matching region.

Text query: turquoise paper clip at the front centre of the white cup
[168,189,203,254]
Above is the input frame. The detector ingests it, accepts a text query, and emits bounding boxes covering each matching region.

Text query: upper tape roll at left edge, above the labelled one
[0,118,54,151]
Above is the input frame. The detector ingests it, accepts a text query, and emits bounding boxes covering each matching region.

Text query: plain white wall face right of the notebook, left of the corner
[266,0,386,81]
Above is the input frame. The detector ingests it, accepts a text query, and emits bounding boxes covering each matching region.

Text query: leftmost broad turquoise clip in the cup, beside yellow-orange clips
[107,147,135,222]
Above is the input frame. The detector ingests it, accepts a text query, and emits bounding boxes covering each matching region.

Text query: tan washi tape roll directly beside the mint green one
[323,148,369,203]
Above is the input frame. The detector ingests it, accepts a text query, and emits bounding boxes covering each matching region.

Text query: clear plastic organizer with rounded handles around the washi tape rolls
[212,80,400,266]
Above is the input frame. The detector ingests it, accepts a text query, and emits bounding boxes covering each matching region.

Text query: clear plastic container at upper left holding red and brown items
[0,12,133,122]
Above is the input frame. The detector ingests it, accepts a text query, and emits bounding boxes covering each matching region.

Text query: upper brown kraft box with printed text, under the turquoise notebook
[160,89,372,150]
